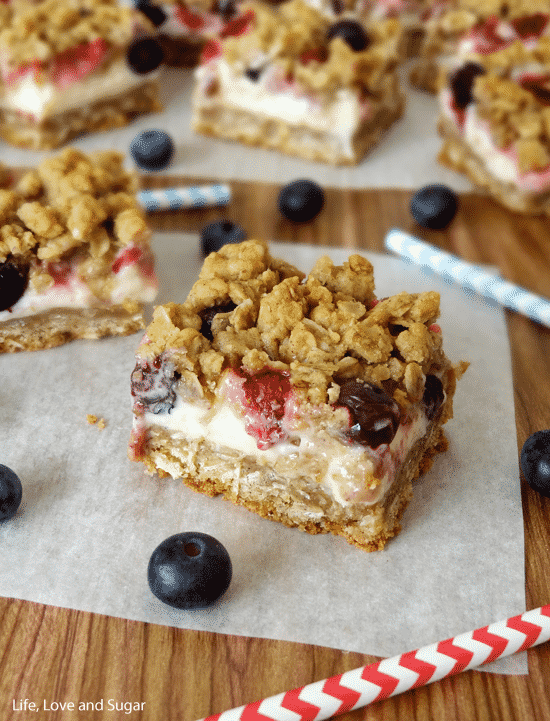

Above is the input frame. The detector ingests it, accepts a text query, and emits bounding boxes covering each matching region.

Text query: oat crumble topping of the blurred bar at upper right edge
[462,37,550,173]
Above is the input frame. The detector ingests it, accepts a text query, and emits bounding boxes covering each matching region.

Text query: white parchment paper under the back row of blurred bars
[0,68,472,191]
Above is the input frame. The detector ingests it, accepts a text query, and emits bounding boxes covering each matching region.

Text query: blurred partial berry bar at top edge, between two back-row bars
[136,0,246,67]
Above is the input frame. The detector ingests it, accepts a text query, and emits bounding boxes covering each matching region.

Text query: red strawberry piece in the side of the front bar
[225,367,294,450]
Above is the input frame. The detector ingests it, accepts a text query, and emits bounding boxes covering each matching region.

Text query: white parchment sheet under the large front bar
[0,238,527,673]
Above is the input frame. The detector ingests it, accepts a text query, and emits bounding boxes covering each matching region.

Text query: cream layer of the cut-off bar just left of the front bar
[0,255,158,322]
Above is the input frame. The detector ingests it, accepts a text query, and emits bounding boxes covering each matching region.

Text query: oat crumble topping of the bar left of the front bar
[0,148,149,298]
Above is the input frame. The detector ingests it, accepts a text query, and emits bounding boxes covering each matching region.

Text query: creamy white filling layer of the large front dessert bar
[143,386,427,506]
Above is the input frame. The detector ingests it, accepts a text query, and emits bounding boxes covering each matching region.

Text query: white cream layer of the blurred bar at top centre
[196,58,374,157]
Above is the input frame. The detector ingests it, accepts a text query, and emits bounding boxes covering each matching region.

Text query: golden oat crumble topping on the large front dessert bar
[138,240,444,407]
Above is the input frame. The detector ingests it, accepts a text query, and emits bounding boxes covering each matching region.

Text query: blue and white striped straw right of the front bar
[384,229,550,327]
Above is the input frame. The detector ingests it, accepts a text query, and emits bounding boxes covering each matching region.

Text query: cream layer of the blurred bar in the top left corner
[0,58,160,120]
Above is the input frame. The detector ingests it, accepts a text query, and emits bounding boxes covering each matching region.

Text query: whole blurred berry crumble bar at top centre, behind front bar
[192,0,404,165]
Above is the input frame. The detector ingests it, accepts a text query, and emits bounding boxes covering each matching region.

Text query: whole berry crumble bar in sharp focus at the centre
[129,240,467,551]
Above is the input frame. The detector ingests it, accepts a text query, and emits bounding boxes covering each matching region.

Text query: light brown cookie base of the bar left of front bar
[0,306,145,353]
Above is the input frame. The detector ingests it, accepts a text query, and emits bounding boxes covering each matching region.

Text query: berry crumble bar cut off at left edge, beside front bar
[0,148,157,352]
